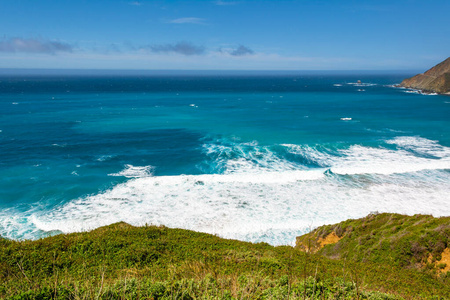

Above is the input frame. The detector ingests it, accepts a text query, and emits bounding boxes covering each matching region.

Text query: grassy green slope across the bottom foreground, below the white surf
[0,215,450,299]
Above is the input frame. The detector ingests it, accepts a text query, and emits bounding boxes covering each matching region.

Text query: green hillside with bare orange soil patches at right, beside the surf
[297,213,450,276]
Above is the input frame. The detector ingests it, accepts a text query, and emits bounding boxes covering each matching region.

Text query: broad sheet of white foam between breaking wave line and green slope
[1,165,450,244]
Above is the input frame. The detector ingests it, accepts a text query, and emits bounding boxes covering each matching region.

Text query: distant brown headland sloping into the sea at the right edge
[400,57,450,95]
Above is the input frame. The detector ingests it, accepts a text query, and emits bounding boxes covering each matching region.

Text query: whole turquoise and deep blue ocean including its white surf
[0,72,450,245]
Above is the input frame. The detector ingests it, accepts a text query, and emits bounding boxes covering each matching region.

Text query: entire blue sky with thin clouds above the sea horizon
[0,0,450,70]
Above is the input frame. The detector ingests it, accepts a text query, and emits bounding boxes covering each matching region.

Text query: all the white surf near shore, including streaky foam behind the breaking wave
[0,137,450,245]
